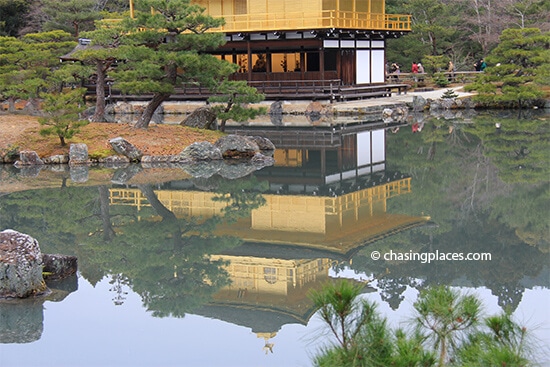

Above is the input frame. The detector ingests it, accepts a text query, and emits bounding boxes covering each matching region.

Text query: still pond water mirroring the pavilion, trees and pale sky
[0,111,550,367]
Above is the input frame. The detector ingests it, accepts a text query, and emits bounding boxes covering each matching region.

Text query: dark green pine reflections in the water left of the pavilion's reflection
[0,174,265,317]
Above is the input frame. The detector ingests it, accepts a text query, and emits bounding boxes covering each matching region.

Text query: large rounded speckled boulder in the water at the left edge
[0,229,48,298]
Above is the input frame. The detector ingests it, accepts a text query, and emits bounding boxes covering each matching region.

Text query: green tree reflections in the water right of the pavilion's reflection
[352,119,550,310]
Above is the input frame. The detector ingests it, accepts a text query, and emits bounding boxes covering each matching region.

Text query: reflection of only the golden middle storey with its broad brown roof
[110,178,428,255]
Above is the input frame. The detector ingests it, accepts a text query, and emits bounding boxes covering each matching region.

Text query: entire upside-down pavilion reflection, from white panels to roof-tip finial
[106,126,429,351]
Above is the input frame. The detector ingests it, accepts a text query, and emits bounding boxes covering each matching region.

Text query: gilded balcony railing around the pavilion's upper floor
[218,10,411,32]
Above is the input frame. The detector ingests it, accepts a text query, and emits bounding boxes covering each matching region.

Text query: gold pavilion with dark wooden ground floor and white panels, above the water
[130,0,411,85]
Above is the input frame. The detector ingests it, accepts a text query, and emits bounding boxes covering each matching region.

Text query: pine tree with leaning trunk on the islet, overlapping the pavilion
[115,0,227,128]
